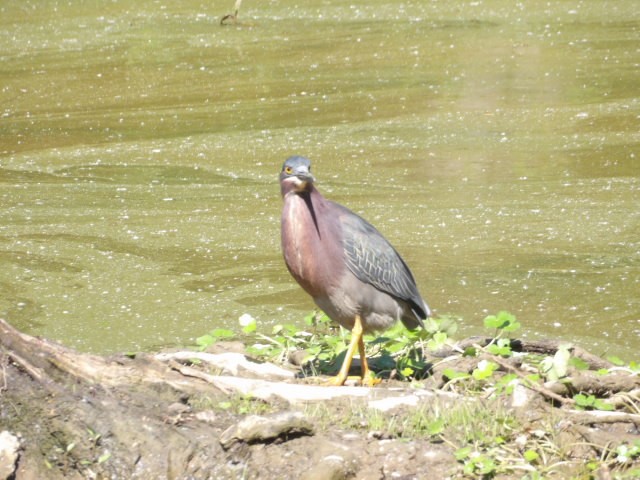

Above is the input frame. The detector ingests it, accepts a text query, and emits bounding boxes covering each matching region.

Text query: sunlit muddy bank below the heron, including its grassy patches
[0,321,640,480]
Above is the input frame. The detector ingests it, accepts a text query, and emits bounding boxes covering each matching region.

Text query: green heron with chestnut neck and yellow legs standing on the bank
[280,156,430,386]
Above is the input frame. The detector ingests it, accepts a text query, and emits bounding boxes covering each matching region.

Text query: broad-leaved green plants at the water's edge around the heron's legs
[196,311,640,416]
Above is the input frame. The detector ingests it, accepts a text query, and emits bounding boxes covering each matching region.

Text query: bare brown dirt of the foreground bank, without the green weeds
[0,321,640,480]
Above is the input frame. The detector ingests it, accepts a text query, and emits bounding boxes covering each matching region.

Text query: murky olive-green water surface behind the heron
[0,0,640,359]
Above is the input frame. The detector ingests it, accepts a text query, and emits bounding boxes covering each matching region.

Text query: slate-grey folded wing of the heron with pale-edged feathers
[339,202,428,319]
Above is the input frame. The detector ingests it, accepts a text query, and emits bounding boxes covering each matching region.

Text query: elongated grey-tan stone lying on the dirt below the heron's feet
[220,412,313,449]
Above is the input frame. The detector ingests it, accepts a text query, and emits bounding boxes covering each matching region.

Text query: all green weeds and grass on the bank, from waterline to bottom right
[197,311,640,480]
